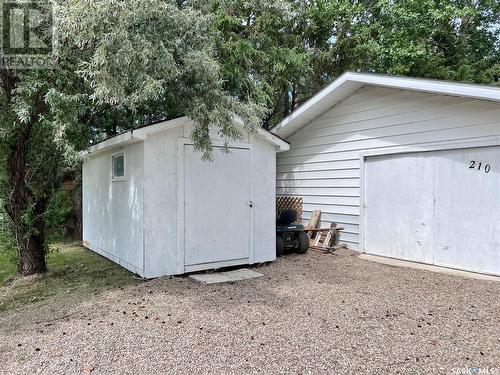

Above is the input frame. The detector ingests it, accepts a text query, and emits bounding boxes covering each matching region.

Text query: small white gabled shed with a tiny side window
[83,117,289,278]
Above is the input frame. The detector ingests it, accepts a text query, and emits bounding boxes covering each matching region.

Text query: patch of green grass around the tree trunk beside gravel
[0,244,138,312]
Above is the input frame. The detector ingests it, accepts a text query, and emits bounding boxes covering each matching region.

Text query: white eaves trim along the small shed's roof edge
[80,116,290,156]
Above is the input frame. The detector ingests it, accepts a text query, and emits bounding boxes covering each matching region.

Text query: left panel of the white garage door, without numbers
[365,154,433,262]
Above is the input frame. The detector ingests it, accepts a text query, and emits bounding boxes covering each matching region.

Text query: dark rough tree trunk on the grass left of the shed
[6,123,47,275]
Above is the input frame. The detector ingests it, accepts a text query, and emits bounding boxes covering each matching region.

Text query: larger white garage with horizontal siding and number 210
[273,73,500,275]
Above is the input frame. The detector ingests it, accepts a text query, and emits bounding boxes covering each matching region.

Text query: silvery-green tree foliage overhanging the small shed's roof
[53,0,263,157]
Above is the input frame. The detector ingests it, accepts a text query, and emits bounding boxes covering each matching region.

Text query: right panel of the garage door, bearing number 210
[434,147,500,273]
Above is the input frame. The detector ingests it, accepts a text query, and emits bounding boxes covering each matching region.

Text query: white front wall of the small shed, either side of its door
[144,122,276,277]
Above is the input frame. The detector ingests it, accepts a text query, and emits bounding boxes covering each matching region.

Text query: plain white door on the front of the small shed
[184,145,251,271]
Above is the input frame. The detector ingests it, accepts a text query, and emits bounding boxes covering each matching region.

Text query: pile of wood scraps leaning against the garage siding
[305,210,347,253]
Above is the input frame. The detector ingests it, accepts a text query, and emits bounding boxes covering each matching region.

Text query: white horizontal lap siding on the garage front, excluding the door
[277,86,500,248]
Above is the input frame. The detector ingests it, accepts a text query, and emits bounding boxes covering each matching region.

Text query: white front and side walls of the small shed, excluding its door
[83,122,276,278]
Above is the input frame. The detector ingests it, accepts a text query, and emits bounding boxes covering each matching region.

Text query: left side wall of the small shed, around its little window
[83,142,144,276]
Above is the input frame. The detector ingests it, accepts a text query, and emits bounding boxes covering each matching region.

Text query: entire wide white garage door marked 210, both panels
[363,147,500,275]
